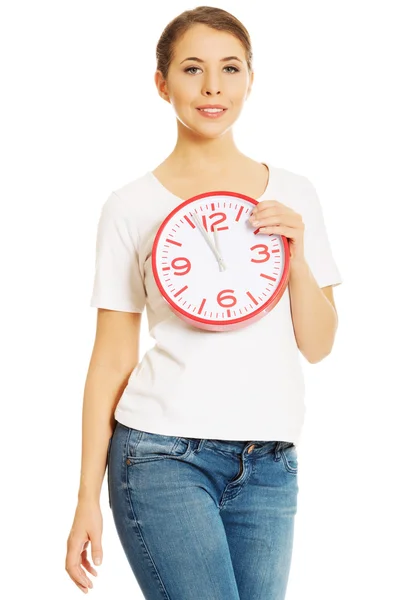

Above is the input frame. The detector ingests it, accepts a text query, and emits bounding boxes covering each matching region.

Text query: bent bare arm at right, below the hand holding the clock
[289,260,338,363]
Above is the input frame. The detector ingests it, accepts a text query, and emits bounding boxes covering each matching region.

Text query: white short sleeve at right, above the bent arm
[303,178,343,288]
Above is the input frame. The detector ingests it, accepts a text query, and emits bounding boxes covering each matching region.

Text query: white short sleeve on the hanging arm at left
[90,192,146,313]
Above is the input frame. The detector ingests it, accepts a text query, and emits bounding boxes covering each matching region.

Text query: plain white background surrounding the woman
[0,0,400,600]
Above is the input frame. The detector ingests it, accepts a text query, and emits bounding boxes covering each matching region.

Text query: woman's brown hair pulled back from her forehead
[156,6,253,79]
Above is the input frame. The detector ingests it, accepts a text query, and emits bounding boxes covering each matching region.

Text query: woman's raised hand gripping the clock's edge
[249,200,305,263]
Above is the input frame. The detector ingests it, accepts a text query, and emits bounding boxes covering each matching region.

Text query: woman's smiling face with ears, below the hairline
[156,24,253,137]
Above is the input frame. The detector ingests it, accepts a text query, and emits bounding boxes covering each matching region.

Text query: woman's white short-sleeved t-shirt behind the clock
[90,165,342,444]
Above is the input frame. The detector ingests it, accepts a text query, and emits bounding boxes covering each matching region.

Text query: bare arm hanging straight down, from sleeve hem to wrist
[78,308,141,503]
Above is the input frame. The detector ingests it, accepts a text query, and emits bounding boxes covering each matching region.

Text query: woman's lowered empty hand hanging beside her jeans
[65,500,103,594]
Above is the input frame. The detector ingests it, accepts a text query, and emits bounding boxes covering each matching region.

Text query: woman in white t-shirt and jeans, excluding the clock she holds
[66,7,341,600]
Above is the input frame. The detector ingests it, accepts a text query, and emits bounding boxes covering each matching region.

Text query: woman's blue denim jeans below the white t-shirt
[107,422,298,600]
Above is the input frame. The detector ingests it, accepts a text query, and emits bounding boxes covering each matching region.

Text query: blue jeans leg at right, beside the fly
[216,441,298,600]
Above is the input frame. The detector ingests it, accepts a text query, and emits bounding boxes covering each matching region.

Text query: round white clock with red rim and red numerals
[152,192,289,330]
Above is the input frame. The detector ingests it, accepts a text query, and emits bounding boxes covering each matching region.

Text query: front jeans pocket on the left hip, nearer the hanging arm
[126,428,191,465]
